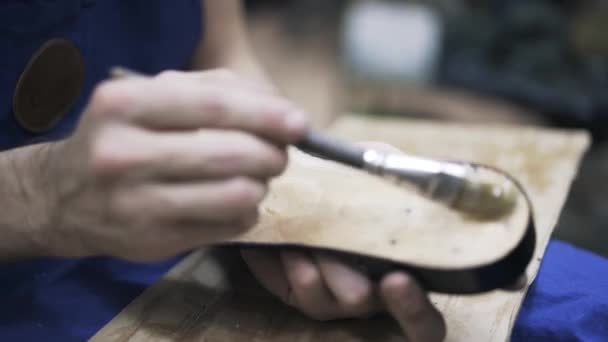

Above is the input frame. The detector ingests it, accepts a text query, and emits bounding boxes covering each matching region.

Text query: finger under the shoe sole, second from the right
[315,256,380,317]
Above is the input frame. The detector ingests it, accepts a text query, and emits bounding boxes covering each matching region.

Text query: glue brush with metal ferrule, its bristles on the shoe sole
[111,67,518,220]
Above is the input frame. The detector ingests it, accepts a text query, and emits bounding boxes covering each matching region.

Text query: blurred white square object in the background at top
[343,1,442,82]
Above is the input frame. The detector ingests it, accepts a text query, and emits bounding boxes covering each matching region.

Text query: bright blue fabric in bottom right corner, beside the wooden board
[512,241,608,342]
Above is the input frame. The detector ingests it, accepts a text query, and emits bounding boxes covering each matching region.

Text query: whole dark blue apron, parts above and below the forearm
[0,0,202,341]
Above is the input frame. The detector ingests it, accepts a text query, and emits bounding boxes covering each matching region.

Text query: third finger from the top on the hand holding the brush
[111,178,266,224]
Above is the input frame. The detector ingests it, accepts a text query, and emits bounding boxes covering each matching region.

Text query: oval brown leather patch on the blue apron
[13,39,84,133]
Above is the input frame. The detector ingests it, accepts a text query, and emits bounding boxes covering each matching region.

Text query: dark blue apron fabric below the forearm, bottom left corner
[0,258,179,341]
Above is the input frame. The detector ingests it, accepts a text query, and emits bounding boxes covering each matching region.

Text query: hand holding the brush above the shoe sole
[36,71,306,261]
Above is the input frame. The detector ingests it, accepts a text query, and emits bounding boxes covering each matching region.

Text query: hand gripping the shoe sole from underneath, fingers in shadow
[241,250,446,342]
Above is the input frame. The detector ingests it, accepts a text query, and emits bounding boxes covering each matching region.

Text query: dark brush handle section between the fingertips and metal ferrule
[295,129,365,169]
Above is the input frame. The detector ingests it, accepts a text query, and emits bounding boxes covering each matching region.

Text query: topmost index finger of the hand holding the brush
[91,78,307,143]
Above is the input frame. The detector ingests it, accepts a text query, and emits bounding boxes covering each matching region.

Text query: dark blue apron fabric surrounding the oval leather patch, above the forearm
[0,0,202,151]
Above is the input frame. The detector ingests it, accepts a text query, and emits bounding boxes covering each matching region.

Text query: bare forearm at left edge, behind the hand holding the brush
[0,144,52,262]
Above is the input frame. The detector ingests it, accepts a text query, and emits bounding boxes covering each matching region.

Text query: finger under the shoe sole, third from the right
[281,251,341,320]
